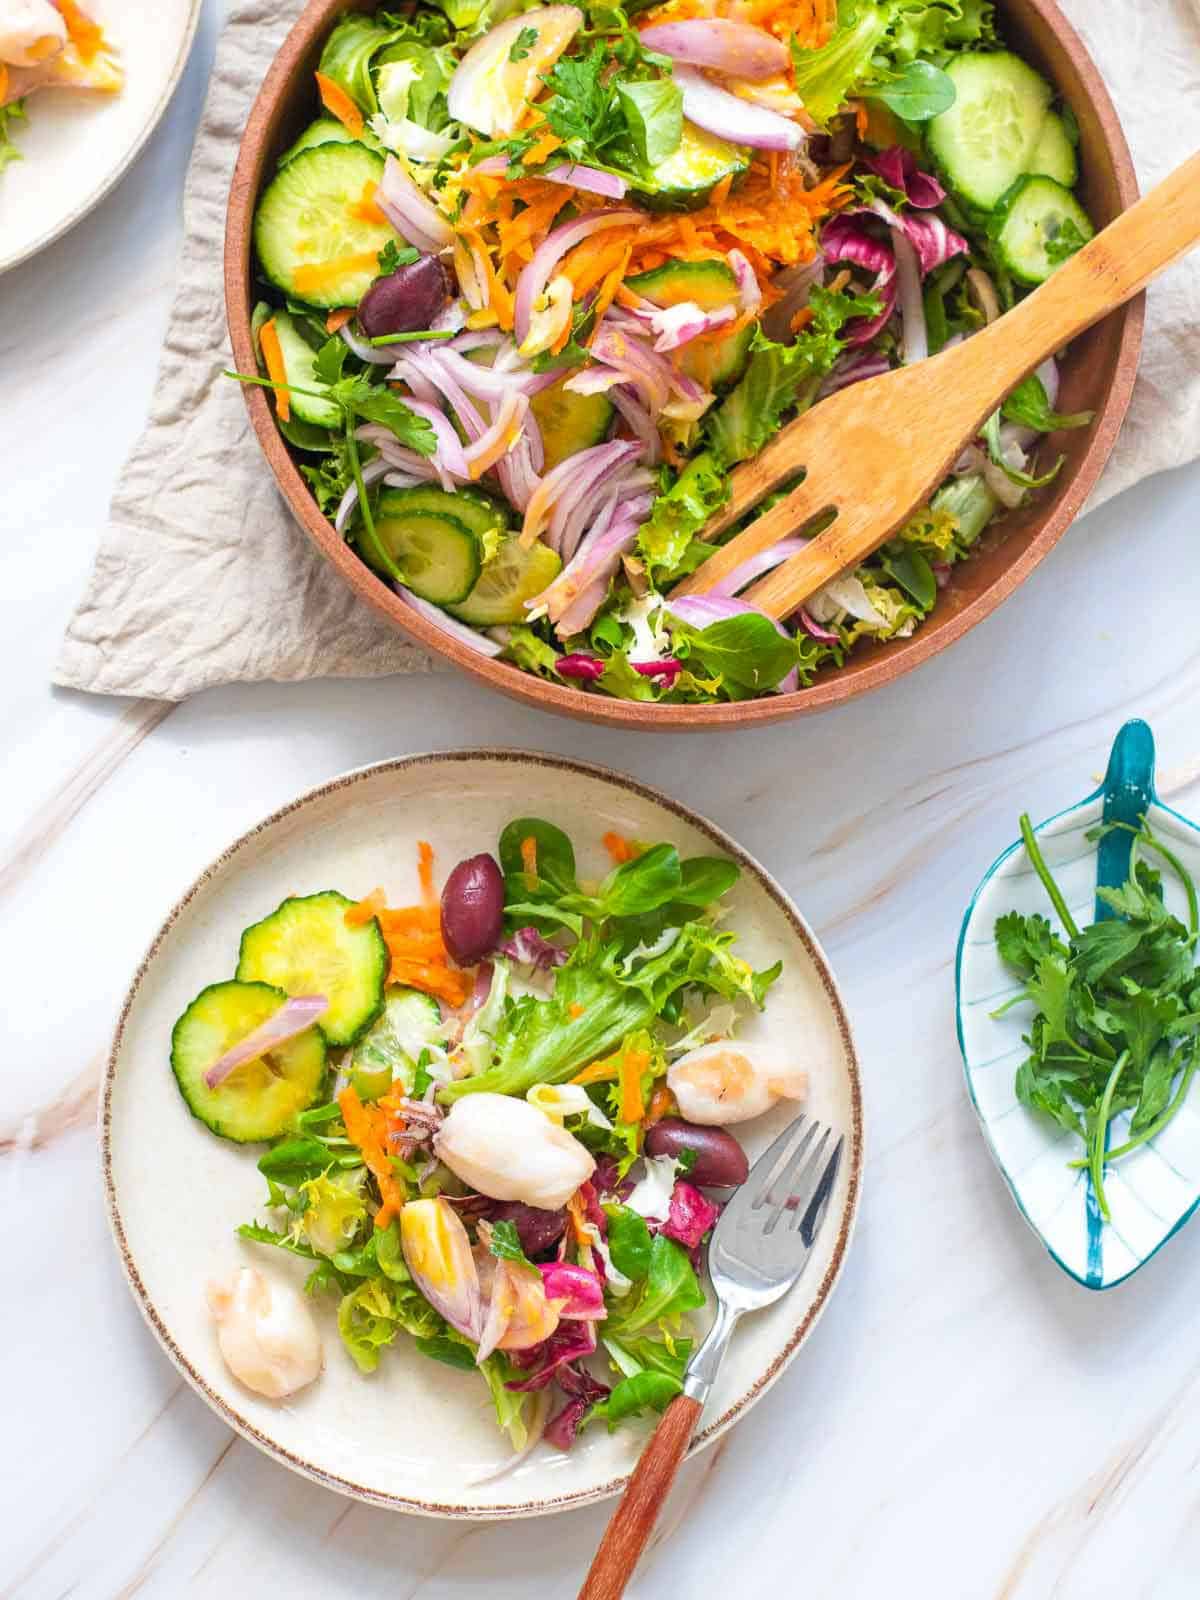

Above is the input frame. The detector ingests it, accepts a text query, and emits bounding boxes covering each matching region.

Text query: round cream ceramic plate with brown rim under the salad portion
[101,750,862,1517]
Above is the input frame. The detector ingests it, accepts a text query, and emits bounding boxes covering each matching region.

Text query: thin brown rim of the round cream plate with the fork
[98,749,862,1522]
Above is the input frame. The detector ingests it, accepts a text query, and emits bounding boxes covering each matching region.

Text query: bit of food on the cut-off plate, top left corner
[0,0,123,173]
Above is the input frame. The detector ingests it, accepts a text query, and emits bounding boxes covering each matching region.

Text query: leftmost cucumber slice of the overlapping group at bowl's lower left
[360,488,483,605]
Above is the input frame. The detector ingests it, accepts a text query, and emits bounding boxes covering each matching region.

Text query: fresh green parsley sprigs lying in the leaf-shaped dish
[994,816,1200,1221]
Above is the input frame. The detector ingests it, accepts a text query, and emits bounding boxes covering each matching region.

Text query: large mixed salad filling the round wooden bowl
[242,0,1093,702]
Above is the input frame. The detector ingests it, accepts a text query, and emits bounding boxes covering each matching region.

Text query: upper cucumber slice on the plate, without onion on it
[237,890,390,1045]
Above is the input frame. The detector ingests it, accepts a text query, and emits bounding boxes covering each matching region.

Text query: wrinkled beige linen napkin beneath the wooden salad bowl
[54,0,1200,699]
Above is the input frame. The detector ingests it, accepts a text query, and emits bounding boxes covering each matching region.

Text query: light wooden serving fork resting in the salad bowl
[672,154,1200,618]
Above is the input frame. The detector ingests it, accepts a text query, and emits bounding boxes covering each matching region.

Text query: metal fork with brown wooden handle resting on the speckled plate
[579,1112,845,1600]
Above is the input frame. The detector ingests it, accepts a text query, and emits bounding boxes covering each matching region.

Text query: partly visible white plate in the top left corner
[0,0,202,272]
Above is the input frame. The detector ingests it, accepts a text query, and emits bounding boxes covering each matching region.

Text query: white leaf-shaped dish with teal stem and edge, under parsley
[955,722,1200,1290]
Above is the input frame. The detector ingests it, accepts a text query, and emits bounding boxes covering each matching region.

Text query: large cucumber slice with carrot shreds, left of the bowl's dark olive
[254,144,397,307]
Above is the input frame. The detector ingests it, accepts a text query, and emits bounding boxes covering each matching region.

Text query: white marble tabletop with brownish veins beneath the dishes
[0,0,1200,1600]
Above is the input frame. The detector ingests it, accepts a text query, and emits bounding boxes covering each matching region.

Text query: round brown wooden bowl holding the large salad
[226,0,1146,730]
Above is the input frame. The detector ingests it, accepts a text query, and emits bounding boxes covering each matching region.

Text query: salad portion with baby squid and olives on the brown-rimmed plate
[171,818,806,1454]
